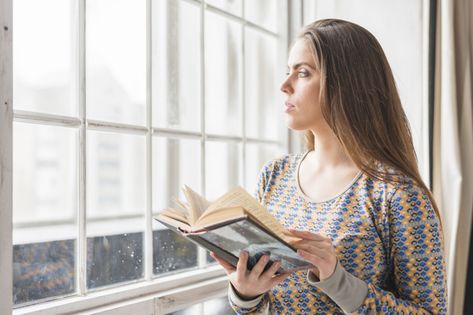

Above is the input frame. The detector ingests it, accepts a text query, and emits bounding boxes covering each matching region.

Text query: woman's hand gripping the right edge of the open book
[289,229,337,280]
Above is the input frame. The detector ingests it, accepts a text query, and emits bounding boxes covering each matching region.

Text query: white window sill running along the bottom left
[13,266,228,315]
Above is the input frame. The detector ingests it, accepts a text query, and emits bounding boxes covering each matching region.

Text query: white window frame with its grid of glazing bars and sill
[0,0,292,315]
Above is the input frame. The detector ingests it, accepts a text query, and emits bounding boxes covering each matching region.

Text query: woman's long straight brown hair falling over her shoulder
[297,19,440,225]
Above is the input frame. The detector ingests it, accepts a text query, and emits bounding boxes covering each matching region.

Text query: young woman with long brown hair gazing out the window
[209,19,447,314]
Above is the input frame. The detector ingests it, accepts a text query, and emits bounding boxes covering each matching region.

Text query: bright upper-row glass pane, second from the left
[85,0,146,125]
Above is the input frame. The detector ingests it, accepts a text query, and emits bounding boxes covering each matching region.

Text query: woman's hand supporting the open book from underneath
[210,251,291,300]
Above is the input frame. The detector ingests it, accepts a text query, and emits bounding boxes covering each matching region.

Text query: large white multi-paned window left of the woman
[9,0,287,313]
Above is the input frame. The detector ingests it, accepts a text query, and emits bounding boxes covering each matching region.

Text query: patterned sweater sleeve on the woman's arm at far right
[353,183,447,314]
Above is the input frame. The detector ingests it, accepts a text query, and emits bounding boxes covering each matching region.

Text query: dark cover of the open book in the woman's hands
[157,216,312,273]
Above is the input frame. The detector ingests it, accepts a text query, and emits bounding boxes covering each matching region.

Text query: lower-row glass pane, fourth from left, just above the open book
[205,141,243,201]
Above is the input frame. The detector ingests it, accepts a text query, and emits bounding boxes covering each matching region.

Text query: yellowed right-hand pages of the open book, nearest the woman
[206,187,294,242]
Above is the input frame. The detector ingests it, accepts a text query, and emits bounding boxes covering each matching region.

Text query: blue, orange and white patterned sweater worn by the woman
[229,152,447,314]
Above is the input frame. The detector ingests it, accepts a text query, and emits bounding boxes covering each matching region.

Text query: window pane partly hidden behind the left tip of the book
[153,137,201,274]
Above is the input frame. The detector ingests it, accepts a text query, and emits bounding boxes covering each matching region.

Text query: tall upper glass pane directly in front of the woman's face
[245,28,278,140]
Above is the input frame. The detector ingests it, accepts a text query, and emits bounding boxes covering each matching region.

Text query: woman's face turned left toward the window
[281,39,325,131]
